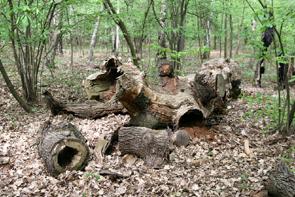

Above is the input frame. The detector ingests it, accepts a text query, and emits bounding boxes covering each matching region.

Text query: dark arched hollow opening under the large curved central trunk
[178,110,204,127]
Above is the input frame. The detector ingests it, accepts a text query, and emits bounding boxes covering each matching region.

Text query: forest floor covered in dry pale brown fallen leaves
[0,51,295,197]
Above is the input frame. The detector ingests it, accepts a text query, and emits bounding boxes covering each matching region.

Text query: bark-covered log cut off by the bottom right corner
[265,162,295,197]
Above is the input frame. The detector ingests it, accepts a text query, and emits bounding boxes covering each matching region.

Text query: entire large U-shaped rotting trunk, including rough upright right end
[116,57,240,128]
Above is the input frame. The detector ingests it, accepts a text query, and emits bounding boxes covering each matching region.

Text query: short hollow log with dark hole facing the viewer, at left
[38,122,89,176]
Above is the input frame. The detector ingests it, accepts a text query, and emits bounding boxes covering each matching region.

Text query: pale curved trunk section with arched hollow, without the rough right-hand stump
[116,64,211,128]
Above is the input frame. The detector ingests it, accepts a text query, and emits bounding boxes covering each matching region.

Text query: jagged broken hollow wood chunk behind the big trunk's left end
[82,57,122,102]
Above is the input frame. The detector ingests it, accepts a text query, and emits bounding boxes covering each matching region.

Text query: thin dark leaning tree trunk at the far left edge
[0,59,32,113]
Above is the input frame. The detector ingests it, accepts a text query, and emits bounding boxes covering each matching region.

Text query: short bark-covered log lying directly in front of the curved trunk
[118,127,170,168]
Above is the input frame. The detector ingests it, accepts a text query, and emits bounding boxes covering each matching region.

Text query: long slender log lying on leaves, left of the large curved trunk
[43,91,126,119]
